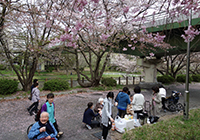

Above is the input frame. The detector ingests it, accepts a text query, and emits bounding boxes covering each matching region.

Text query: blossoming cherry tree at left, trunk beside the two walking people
[0,0,60,91]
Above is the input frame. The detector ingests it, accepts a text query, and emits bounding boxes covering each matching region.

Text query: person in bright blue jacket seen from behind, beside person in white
[115,87,131,118]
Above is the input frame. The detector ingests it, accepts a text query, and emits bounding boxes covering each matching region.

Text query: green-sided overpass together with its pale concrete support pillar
[115,12,200,83]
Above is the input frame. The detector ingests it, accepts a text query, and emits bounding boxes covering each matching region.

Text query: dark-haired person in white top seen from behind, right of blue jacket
[131,86,145,119]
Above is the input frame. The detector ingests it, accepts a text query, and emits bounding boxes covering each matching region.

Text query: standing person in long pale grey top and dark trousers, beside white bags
[102,92,114,140]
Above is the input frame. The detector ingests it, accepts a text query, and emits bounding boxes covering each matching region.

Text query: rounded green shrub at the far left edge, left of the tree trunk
[0,79,18,95]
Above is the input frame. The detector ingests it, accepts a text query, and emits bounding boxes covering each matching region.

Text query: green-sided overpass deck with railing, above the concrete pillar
[116,9,200,58]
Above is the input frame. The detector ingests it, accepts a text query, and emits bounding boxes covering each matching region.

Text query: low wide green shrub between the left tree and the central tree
[43,79,69,91]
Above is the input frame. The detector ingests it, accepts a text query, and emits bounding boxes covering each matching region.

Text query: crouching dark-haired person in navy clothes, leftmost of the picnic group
[83,102,100,129]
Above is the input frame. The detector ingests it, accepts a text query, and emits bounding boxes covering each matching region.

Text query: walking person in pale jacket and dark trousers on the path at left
[27,83,40,116]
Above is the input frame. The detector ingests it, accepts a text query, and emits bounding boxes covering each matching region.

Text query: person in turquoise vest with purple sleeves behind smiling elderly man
[41,93,63,138]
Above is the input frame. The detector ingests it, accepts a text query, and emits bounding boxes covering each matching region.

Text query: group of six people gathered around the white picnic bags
[83,85,166,140]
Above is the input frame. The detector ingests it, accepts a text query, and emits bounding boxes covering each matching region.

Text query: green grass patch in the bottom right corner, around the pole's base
[123,109,200,140]
